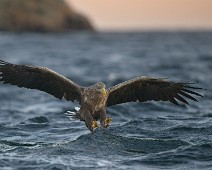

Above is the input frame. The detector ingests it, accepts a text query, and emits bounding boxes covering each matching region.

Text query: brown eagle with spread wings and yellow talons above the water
[0,60,202,132]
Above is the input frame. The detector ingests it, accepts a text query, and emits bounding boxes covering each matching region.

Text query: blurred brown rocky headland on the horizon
[0,0,93,32]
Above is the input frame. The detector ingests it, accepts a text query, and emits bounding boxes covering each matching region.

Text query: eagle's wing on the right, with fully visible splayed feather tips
[107,77,202,106]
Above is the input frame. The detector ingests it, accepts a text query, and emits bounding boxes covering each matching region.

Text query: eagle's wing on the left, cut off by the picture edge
[0,60,81,102]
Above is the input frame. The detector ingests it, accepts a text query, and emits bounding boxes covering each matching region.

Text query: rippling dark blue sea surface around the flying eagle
[0,32,212,170]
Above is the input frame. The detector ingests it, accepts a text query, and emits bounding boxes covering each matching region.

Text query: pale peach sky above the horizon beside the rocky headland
[65,0,212,31]
